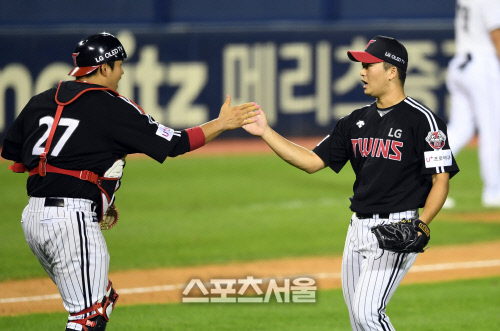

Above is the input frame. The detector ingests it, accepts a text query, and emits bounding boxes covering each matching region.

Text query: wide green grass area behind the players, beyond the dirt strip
[0,150,500,281]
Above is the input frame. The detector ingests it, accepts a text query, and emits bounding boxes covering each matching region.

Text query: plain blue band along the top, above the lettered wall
[0,0,455,26]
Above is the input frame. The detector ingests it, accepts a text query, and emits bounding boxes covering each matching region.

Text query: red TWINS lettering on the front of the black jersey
[351,138,403,161]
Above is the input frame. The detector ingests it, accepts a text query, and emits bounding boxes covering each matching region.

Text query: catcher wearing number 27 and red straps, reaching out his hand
[1,32,260,331]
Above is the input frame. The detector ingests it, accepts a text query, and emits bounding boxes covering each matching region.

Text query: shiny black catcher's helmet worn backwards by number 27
[68,32,127,77]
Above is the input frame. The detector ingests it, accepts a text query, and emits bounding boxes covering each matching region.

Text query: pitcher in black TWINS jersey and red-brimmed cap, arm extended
[244,36,458,331]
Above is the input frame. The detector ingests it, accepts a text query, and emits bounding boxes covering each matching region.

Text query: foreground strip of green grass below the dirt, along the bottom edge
[0,277,500,331]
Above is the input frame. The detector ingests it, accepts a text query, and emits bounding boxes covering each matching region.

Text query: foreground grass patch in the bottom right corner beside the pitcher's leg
[387,277,500,331]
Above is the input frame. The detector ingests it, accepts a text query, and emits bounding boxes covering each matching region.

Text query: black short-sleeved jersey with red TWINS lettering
[313,97,459,213]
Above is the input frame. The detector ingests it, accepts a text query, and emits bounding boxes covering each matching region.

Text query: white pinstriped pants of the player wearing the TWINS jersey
[342,210,418,331]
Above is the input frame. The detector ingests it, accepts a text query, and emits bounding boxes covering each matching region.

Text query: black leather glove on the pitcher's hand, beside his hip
[371,218,431,253]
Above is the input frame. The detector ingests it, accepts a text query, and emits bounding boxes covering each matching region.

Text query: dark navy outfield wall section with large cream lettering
[0,21,453,141]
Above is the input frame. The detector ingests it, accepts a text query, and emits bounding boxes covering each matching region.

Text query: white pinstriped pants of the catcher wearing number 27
[21,197,109,330]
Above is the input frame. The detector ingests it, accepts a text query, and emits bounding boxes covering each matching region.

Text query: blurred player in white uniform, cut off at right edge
[447,0,500,207]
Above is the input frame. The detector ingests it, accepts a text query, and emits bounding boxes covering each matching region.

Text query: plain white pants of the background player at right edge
[446,54,500,201]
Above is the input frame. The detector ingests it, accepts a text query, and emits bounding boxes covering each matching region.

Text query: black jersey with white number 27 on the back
[2,81,190,202]
